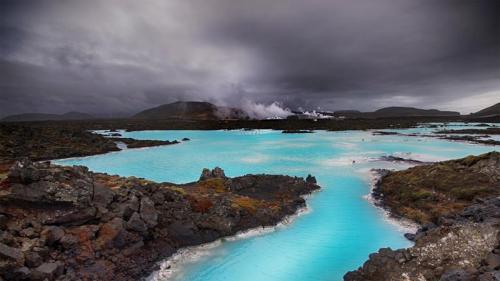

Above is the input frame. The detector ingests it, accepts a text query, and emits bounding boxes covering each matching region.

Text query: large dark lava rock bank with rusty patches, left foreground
[0,160,319,280]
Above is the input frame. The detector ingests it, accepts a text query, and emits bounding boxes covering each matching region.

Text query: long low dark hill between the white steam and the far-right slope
[334,106,460,118]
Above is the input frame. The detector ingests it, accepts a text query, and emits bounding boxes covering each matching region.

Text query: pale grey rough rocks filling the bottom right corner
[344,197,500,281]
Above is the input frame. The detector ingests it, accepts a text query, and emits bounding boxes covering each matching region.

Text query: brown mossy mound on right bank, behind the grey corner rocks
[373,152,500,224]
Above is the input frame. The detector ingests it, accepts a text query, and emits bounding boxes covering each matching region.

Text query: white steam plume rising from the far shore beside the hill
[241,100,293,119]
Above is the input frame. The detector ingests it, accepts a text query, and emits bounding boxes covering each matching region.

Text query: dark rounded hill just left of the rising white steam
[133,101,248,120]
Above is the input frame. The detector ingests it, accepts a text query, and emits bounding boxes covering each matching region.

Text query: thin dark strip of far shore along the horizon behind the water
[0,117,464,131]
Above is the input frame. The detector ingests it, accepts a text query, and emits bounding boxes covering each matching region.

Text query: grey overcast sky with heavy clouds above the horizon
[0,0,500,116]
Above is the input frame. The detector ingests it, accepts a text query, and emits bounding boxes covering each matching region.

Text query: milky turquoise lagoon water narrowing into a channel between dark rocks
[57,129,494,281]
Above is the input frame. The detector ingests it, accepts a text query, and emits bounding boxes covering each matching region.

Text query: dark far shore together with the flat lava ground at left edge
[0,117,500,164]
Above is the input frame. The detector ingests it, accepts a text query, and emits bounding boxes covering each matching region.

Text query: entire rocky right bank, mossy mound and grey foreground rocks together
[344,152,500,281]
